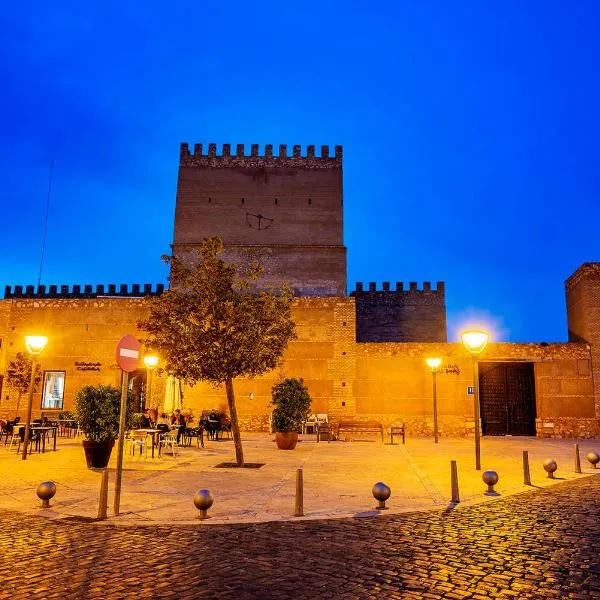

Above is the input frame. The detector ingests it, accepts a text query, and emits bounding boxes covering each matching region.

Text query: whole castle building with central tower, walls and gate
[0,144,600,437]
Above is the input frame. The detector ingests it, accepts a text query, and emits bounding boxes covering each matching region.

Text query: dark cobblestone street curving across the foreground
[0,476,600,599]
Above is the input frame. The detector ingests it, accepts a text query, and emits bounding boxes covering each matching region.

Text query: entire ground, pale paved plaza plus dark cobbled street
[0,434,600,600]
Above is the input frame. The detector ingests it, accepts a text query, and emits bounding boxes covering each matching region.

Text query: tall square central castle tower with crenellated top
[173,144,346,296]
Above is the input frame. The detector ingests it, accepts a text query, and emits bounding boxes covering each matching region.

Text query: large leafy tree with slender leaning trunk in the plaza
[138,237,295,467]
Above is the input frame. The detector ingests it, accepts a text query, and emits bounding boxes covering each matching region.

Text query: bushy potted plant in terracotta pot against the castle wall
[271,377,311,450]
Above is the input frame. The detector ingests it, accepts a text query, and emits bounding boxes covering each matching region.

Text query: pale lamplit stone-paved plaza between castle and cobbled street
[0,434,600,525]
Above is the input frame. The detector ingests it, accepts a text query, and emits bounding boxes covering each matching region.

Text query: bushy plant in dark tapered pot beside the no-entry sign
[75,385,132,469]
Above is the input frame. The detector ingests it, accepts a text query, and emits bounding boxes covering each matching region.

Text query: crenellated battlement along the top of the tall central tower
[179,142,342,169]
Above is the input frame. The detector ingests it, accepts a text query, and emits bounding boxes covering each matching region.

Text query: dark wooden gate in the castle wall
[479,363,535,435]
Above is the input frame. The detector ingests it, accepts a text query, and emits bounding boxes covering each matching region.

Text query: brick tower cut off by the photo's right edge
[565,262,600,418]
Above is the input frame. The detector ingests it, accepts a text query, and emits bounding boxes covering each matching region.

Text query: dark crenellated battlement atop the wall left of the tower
[4,283,165,300]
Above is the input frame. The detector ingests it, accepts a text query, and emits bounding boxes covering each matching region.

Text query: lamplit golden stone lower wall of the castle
[0,297,598,436]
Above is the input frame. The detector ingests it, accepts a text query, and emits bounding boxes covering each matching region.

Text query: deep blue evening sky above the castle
[0,0,600,341]
